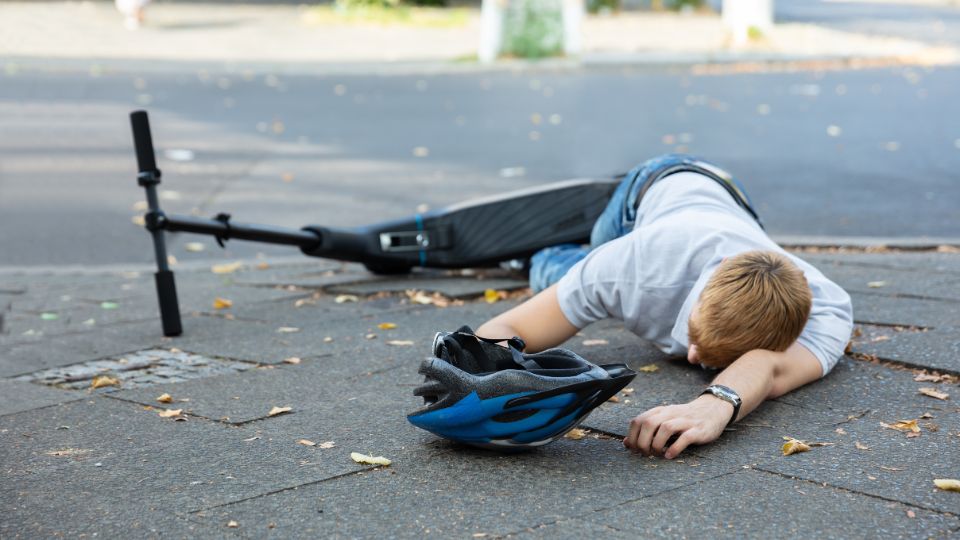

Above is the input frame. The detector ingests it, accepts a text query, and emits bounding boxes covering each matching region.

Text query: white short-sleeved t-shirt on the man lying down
[557,172,853,375]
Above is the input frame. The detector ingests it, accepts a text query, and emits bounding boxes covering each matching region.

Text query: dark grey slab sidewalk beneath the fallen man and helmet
[0,248,960,538]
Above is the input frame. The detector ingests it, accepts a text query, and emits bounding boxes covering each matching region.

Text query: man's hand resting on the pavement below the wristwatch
[623,394,733,459]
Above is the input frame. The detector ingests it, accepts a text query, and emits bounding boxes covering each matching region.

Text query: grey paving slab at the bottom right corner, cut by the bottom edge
[532,470,960,539]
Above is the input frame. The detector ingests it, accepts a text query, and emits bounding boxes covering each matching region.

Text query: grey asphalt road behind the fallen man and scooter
[0,62,960,266]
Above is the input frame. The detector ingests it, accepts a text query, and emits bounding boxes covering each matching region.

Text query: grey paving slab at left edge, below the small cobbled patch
[0,397,386,515]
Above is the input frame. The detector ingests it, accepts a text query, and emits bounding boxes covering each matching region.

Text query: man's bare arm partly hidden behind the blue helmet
[477,285,578,352]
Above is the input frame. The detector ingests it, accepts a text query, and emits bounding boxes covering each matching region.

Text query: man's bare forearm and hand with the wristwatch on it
[623,343,823,459]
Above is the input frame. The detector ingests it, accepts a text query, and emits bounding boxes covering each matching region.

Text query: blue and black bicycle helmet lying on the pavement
[407,326,636,450]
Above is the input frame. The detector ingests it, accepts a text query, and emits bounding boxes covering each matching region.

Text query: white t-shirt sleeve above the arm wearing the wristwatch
[797,275,853,375]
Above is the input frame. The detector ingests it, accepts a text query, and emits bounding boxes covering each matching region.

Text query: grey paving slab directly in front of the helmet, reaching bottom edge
[189,438,726,538]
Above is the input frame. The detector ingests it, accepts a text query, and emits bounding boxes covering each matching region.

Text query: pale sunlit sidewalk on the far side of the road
[0,2,960,71]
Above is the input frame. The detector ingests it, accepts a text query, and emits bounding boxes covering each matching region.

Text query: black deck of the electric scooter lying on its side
[301,178,619,273]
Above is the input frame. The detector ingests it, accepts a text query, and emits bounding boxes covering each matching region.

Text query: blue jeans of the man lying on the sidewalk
[530,154,759,292]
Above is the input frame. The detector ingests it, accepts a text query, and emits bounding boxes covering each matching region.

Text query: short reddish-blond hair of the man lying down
[688,251,813,368]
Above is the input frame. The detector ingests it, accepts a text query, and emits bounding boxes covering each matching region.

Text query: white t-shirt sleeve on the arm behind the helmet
[557,235,635,328]
